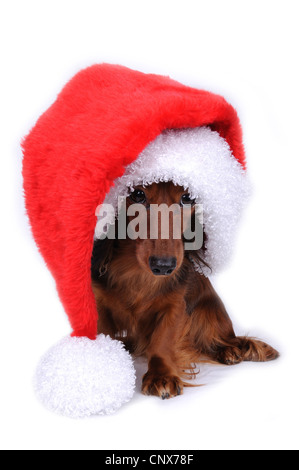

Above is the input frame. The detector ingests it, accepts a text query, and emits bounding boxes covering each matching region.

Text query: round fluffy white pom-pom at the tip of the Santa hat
[34,335,136,418]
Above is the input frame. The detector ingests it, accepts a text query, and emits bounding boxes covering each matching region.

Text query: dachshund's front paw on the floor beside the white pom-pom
[142,371,184,400]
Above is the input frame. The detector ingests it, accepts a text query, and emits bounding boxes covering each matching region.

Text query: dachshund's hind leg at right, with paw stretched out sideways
[190,276,279,365]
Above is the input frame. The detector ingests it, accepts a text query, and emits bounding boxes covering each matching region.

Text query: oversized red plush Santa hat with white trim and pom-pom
[23,64,248,416]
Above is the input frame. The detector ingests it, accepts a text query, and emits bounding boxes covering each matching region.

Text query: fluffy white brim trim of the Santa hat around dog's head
[95,127,249,276]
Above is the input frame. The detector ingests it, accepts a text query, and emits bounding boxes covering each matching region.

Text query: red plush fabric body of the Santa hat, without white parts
[23,64,245,339]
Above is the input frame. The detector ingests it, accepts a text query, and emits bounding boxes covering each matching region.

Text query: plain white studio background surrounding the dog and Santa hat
[0,0,299,450]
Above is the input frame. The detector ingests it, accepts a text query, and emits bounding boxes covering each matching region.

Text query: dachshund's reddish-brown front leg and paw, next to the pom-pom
[142,299,186,400]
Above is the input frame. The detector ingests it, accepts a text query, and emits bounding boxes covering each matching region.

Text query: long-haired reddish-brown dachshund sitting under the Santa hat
[92,182,278,399]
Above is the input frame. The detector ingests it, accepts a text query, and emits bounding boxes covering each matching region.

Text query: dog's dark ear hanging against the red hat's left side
[91,238,114,281]
